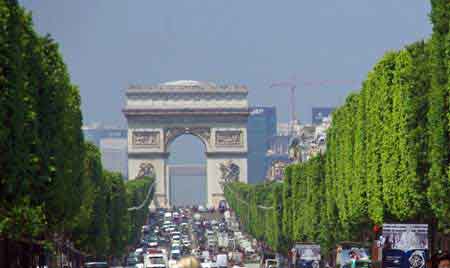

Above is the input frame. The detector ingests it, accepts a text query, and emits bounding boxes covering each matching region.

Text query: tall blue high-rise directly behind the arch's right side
[247,107,277,183]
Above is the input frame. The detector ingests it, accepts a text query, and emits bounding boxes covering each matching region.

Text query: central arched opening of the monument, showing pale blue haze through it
[167,133,207,206]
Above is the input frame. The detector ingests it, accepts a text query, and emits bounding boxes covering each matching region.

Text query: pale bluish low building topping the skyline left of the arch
[82,124,128,147]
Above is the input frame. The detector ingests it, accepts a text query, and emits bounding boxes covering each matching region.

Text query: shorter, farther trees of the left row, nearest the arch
[71,143,154,257]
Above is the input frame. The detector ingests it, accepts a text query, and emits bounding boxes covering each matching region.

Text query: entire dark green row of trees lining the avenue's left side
[0,0,152,262]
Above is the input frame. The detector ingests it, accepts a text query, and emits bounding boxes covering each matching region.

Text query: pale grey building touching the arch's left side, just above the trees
[100,138,128,178]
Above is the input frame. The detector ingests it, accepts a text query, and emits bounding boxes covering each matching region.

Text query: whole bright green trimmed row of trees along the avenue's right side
[227,0,450,254]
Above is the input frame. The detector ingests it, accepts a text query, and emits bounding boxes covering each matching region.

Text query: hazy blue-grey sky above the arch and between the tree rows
[20,0,431,124]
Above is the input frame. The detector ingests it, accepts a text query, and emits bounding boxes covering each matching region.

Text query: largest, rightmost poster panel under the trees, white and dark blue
[380,224,428,268]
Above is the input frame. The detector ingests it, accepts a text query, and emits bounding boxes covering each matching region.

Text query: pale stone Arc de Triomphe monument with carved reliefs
[123,81,249,207]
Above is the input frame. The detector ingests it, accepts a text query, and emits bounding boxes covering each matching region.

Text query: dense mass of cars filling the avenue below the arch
[124,206,260,268]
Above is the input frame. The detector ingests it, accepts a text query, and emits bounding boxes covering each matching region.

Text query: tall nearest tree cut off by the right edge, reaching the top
[427,0,450,229]
